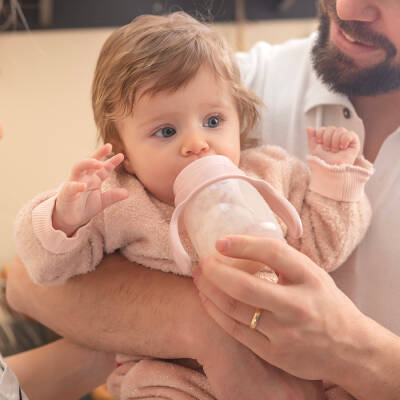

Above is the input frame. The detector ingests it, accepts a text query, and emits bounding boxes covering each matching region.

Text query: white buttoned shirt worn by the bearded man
[237,34,400,335]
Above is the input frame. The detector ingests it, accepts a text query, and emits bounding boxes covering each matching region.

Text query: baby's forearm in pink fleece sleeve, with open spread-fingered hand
[15,145,127,285]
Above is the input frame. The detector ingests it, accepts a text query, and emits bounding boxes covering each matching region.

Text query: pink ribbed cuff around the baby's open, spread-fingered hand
[32,195,90,254]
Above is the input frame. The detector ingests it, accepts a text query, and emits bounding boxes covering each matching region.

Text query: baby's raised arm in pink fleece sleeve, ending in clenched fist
[287,127,373,271]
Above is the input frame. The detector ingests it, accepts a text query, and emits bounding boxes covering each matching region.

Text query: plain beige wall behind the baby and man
[0,20,315,268]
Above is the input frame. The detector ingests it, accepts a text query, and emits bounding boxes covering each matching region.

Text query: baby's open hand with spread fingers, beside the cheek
[53,144,128,236]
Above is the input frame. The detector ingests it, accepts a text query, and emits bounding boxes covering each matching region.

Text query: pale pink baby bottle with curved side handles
[169,155,302,275]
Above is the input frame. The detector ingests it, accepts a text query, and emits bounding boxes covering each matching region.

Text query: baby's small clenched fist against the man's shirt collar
[307,126,360,165]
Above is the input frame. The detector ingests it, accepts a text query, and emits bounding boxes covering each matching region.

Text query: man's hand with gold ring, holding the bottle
[194,236,368,382]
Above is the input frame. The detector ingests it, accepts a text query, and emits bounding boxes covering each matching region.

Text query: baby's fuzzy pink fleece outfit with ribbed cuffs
[15,146,373,399]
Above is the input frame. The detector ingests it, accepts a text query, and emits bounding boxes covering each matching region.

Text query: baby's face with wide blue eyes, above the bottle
[117,68,240,204]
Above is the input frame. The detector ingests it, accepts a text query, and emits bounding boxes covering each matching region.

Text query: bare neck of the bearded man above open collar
[351,90,400,162]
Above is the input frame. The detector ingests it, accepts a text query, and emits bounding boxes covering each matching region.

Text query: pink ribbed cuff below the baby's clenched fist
[307,156,374,202]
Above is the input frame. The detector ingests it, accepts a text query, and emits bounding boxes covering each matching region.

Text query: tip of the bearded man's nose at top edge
[336,0,381,22]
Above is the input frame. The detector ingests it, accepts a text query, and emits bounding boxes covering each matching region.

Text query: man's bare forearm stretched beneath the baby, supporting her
[7,255,321,400]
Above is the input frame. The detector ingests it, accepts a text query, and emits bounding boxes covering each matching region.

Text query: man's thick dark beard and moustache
[312,0,400,96]
